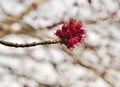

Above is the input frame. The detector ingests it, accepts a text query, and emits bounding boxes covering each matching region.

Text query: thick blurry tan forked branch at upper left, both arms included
[0,0,45,38]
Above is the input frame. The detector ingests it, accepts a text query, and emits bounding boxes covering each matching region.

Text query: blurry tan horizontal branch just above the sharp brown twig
[0,23,40,38]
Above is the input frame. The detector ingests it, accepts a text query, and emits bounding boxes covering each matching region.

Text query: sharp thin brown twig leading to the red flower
[0,39,60,47]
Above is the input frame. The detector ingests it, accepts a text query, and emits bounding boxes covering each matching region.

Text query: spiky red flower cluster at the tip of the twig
[55,19,86,50]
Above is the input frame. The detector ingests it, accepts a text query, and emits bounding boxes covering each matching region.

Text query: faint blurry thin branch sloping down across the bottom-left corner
[0,64,51,87]
